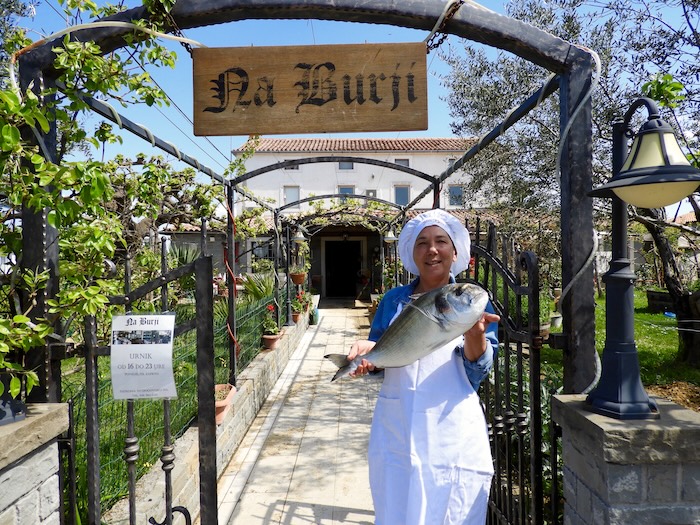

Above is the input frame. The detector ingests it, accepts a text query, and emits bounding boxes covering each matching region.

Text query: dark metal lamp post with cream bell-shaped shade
[587,98,700,419]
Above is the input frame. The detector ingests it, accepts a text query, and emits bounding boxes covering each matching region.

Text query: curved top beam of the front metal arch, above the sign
[22,0,588,76]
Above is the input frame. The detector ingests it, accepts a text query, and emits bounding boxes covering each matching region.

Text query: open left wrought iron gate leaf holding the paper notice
[64,256,217,525]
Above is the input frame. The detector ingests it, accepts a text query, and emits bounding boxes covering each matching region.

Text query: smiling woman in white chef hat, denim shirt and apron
[348,210,500,525]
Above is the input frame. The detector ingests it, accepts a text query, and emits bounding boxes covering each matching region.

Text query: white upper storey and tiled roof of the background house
[234,138,473,213]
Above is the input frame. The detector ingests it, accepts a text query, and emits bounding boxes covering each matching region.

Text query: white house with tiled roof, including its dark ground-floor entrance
[234,138,474,297]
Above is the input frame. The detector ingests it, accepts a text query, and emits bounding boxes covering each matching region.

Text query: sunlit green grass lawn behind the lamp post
[542,284,700,386]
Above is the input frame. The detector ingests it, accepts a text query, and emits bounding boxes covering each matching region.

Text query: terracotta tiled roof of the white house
[234,138,476,153]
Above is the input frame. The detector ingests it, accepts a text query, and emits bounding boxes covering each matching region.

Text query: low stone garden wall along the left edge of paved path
[102,315,309,525]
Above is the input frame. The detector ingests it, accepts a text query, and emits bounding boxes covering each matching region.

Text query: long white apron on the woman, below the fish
[368,306,493,525]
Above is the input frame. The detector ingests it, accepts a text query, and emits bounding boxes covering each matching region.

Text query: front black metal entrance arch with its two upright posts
[19,0,595,392]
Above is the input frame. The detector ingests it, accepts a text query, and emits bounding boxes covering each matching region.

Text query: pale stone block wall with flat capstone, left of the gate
[0,403,68,525]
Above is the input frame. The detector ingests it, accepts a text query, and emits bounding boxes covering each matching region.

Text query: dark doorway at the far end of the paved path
[325,241,362,297]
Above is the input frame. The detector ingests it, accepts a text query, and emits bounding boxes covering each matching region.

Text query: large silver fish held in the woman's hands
[324,283,488,381]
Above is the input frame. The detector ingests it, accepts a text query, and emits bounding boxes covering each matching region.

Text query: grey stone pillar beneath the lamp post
[552,395,700,525]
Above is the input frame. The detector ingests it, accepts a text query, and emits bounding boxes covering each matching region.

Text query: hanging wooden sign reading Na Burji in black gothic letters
[192,42,428,136]
